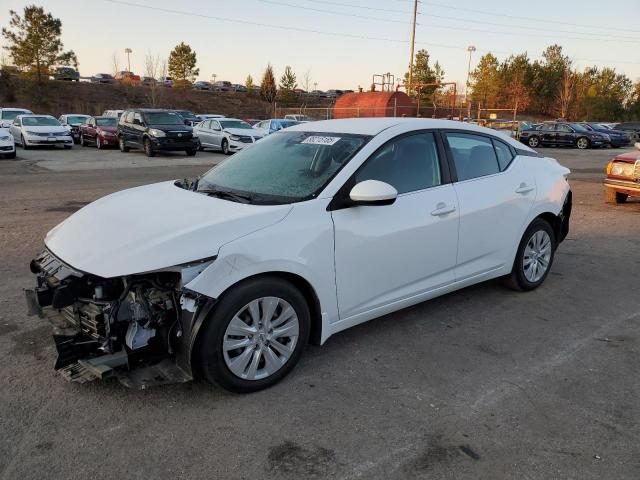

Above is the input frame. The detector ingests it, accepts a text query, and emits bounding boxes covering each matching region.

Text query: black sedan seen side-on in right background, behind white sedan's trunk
[520,122,611,149]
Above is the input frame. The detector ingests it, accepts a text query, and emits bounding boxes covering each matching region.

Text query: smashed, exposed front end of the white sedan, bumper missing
[25,250,212,388]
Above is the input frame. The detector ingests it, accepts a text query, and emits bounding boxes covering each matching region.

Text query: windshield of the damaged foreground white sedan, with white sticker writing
[198,131,370,203]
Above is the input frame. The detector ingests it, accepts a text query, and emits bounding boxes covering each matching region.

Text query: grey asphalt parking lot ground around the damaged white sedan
[0,147,640,480]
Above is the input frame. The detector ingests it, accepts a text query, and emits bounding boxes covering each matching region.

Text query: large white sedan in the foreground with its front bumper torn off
[27,118,571,392]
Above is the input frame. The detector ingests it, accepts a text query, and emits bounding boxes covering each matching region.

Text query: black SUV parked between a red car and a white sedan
[118,108,198,157]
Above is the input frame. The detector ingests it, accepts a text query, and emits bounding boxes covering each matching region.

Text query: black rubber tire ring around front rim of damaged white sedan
[195,277,311,393]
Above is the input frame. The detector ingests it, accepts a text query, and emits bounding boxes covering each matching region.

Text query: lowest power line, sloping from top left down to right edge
[92,0,640,65]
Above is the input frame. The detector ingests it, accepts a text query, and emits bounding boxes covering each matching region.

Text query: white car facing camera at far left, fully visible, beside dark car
[9,115,73,150]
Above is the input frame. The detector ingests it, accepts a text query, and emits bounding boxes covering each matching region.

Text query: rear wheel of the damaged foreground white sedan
[507,218,556,291]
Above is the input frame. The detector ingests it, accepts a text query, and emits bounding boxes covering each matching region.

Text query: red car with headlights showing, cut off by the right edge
[604,143,640,203]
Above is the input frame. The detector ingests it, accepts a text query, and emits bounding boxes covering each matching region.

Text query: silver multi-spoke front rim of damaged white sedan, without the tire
[222,297,300,380]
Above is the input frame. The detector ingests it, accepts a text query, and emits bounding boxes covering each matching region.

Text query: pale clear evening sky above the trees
[0,0,640,90]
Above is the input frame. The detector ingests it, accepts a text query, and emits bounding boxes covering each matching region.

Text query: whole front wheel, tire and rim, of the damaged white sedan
[198,277,311,393]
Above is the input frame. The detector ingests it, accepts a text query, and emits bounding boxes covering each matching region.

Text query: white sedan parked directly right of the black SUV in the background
[193,118,263,155]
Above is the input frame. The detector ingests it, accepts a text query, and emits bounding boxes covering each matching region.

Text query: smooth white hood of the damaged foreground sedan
[45,181,292,278]
